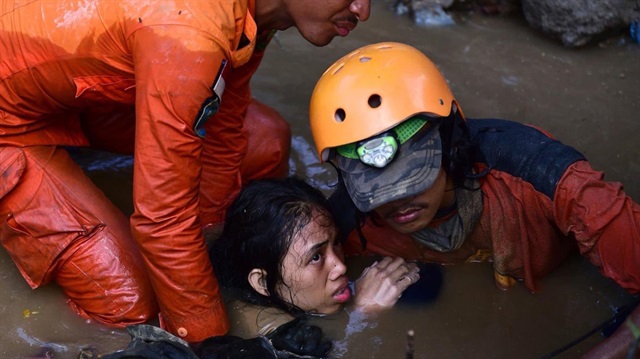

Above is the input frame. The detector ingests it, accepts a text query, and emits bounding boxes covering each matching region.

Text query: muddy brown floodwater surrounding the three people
[0,0,640,358]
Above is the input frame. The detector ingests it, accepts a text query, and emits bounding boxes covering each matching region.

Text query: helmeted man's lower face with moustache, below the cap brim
[374,169,454,233]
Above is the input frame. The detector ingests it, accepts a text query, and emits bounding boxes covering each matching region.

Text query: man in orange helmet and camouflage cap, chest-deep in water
[310,43,640,353]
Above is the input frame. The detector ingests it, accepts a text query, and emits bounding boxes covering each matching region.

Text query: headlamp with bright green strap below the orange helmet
[336,117,428,168]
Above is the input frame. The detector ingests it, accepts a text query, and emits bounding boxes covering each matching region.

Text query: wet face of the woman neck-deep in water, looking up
[276,212,351,314]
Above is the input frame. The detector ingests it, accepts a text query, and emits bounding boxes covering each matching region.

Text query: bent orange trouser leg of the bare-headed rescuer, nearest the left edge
[0,146,158,327]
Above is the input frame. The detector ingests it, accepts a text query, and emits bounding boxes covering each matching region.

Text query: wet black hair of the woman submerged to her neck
[209,177,334,315]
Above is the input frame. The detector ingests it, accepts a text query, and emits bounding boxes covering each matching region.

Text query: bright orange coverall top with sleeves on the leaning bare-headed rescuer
[0,0,266,340]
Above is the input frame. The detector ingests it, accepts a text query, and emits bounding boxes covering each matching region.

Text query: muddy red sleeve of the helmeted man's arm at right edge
[554,161,640,294]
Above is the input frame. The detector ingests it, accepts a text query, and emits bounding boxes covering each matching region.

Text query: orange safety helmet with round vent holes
[309,42,464,162]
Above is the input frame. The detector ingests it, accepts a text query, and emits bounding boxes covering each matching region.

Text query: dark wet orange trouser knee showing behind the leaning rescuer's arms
[240,99,291,183]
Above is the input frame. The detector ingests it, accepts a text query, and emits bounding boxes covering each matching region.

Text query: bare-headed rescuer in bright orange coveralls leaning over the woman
[0,0,370,342]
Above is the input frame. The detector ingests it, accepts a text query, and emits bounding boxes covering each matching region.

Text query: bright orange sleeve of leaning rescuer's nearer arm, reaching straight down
[129,26,229,342]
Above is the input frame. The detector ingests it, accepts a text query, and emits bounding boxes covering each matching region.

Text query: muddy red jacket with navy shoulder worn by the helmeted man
[338,119,640,293]
